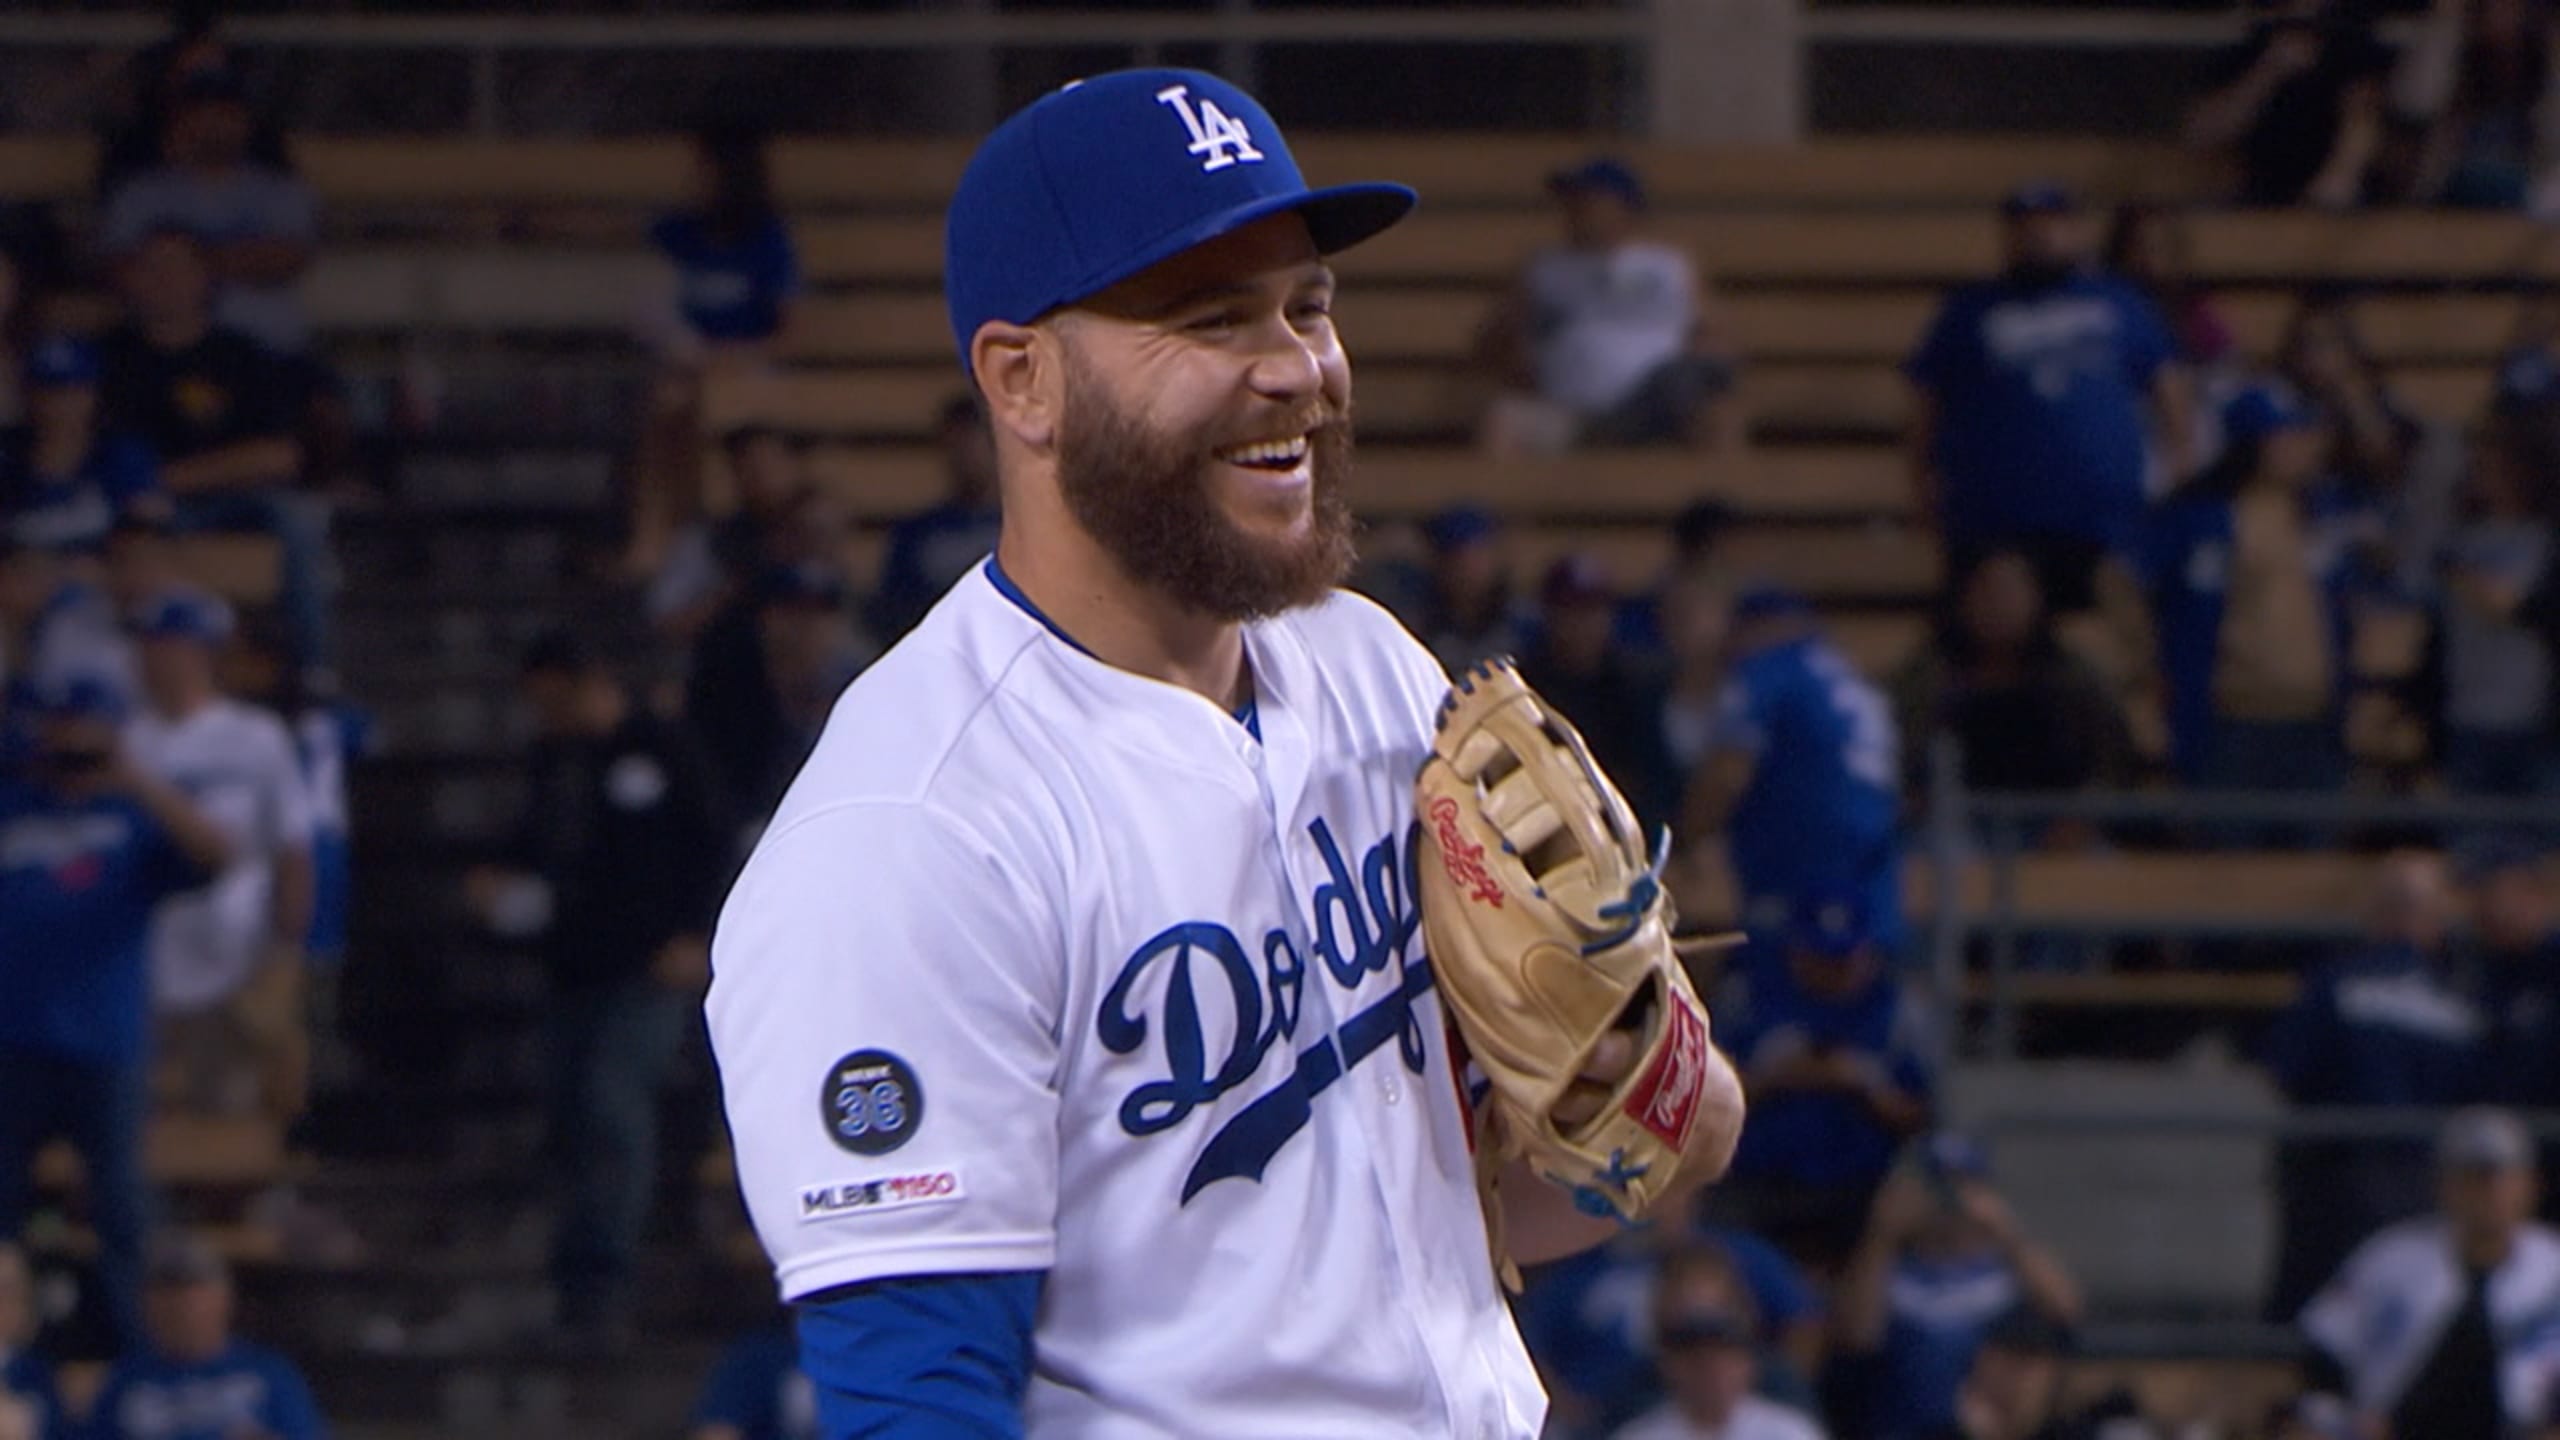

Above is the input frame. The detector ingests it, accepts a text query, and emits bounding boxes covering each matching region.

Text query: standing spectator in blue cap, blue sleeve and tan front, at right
[2145,387,2348,789]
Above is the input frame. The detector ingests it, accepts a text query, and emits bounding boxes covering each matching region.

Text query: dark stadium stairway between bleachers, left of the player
[202,361,765,1440]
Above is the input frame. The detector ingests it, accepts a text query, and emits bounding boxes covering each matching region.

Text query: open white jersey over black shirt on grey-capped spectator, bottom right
[2301,1215,2560,1425]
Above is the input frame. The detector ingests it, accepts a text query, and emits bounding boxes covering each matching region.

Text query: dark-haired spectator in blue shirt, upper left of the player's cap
[648,131,801,346]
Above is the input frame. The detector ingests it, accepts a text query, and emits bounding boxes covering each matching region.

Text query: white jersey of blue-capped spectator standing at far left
[125,697,312,1010]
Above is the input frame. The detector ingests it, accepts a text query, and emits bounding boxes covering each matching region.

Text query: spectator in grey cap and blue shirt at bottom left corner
[90,1219,328,1440]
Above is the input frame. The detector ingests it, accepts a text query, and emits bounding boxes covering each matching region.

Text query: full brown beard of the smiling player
[1057,361,1354,620]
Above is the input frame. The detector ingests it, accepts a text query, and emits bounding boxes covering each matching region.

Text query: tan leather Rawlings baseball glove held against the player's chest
[1416,661,1741,1279]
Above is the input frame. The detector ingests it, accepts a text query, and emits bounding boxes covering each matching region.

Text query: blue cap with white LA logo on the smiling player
[942,69,1418,369]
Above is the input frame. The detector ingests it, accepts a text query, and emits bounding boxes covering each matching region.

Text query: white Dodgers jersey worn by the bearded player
[709,566,1546,1440]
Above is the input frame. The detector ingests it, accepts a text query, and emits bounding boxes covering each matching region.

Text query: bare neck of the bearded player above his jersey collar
[996,530,1247,710]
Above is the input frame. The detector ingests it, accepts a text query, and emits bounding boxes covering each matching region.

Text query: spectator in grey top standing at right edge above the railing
[2440,423,2560,797]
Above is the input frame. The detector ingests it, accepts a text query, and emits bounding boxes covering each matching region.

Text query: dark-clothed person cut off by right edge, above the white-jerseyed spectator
[2465,843,2560,1109]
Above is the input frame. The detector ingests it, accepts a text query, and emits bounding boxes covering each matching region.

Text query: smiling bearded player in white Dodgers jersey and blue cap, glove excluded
[707,69,1741,1440]
